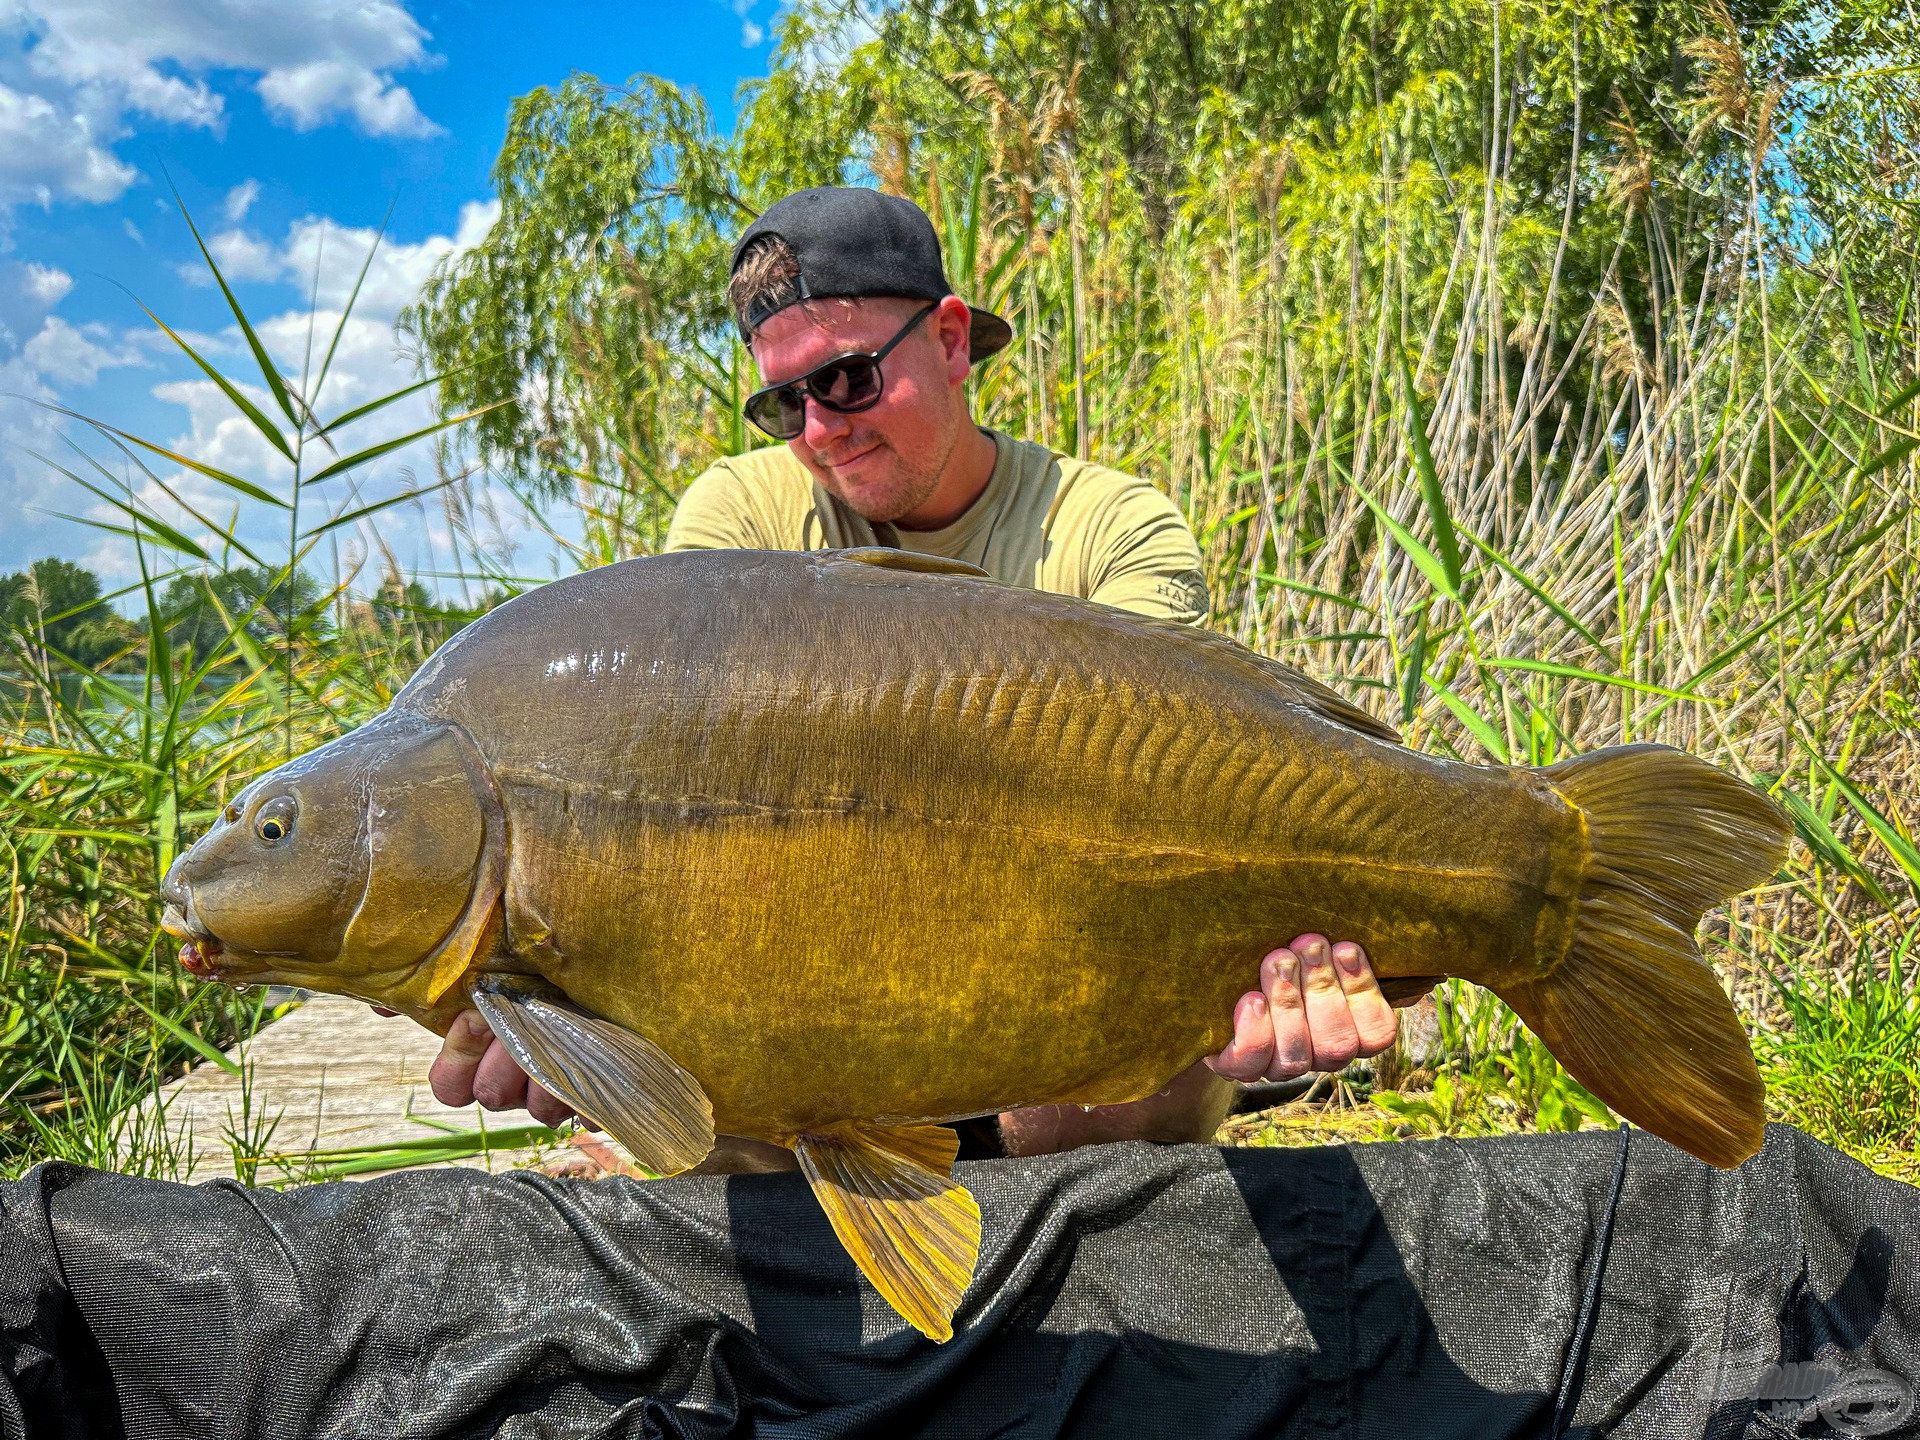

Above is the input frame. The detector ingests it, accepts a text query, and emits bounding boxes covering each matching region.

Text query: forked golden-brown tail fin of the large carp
[1498,745,1789,1169]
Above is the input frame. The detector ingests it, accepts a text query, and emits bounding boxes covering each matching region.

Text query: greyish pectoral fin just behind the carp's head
[472,975,714,1175]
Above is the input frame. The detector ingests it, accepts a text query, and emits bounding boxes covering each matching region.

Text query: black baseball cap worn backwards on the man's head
[728,184,1014,363]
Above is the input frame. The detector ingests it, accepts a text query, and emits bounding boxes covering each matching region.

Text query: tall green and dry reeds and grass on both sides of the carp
[0,100,1920,1173]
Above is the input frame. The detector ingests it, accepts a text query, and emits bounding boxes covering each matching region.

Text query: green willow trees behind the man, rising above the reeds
[409,0,1912,555]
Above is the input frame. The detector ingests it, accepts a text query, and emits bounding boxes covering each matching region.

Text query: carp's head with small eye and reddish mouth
[161,712,503,1004]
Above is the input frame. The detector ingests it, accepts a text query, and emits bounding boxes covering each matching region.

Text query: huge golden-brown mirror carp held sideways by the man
[165,549,1788,1338]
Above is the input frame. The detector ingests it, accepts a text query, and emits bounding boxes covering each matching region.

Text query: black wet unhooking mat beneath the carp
[0,1127,1920,1440]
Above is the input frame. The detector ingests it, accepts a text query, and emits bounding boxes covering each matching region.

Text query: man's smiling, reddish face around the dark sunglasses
[753,298,968,524]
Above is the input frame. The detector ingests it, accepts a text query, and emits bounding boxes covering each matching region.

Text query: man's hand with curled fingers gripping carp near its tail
[1206,935,1400,1085]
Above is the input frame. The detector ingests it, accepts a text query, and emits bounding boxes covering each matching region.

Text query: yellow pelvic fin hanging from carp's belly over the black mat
[793,1125,979,1340]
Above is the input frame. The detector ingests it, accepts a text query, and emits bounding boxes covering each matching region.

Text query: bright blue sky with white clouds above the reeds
[0,0,780,584]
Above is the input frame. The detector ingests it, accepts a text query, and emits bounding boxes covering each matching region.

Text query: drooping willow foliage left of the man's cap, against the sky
[403,75,751,545]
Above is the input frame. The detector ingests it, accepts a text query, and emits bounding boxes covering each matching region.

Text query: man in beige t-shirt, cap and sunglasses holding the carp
[432,186,1396,1154]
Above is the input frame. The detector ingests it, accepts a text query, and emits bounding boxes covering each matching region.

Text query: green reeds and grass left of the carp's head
[0,205,495,1173]
